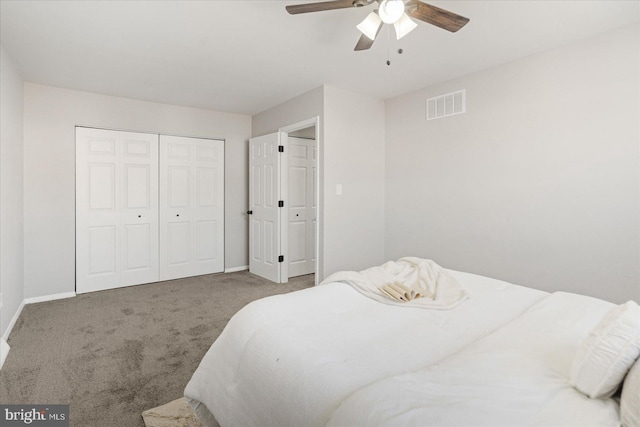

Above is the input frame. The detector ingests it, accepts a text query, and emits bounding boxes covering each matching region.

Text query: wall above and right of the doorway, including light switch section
[252,86,384,280]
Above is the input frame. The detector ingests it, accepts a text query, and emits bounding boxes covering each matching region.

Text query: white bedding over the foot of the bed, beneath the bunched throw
[185,270,547,427]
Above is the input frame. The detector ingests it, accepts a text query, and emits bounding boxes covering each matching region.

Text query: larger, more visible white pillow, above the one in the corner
[569,301,640,398]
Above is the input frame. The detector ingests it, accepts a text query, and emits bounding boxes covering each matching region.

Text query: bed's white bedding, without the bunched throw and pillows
[185,260,640,426]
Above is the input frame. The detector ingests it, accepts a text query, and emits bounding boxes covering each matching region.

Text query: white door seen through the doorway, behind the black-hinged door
[287,136,317,277]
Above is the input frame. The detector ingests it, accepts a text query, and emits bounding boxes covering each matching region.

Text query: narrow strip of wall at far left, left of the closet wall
[0,45,24,336]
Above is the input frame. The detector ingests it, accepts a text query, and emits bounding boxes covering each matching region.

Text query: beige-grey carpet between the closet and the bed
[0,271,314,427]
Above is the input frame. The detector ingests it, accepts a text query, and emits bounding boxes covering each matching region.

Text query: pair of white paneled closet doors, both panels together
[76,127,224,293]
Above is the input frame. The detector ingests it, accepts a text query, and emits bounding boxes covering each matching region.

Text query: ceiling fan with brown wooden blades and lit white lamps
[286,0,469,50]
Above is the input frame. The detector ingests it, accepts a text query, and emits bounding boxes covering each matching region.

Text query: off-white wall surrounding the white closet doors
[24,83,251,298]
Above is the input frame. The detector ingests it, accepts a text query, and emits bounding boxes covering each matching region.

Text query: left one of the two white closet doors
[76,127,158,293]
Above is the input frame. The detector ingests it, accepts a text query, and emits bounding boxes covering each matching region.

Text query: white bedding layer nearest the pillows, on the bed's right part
[329,292,620,427]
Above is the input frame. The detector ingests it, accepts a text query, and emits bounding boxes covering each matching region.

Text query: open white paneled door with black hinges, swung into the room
[248,132,286,283]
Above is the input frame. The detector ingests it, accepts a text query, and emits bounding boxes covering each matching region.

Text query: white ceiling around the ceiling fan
[0,0,640,114]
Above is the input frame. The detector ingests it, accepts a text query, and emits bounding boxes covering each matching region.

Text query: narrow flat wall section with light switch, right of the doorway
[324,86,385,275]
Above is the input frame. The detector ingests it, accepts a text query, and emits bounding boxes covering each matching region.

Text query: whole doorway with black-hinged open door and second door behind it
[247,117,322,284]
